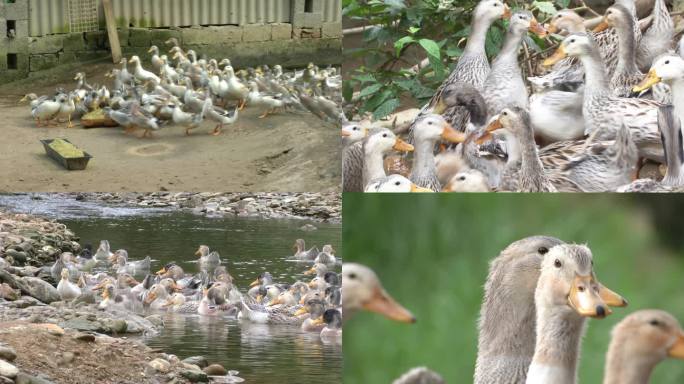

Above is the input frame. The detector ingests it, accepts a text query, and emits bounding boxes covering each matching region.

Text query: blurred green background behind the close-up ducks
[343,193,684,383]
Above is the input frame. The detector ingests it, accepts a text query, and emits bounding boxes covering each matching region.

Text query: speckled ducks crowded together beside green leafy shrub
[342,0,684,192]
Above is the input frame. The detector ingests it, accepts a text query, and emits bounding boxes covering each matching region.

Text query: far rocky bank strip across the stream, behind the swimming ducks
[67,192,342,223]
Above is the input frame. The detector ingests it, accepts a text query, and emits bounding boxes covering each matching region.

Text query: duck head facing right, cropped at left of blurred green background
[342,263,416,323]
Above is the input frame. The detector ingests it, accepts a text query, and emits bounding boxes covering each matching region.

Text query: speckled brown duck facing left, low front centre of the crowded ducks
[487,107,557,192]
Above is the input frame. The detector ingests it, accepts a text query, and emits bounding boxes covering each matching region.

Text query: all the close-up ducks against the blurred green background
[342,236,684,384]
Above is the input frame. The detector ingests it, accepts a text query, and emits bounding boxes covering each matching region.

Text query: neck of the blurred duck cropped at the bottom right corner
[603,338,660,384]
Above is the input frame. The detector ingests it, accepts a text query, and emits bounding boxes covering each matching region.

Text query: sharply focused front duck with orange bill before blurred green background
[525,244,627,384]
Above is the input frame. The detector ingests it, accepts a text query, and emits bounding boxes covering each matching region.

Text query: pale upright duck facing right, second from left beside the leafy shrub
[482,10,546,116]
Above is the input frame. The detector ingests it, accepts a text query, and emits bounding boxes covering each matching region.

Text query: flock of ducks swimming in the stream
[51,239,342,343]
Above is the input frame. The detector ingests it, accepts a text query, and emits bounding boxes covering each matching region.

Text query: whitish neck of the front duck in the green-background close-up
[527,306,586,384]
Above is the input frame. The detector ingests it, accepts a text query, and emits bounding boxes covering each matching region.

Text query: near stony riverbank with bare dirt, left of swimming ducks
[0,211,250,384]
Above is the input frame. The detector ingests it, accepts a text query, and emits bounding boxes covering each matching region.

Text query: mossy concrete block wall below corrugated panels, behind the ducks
[0,0,342,82]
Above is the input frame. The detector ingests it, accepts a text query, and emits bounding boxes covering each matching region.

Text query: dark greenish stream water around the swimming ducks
[0,195,342,384]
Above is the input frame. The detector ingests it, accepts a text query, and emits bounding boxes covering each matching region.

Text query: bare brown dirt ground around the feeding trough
[0,64,340,192]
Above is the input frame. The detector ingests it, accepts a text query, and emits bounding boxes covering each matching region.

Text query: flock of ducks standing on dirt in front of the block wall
[22,38,341,137]
